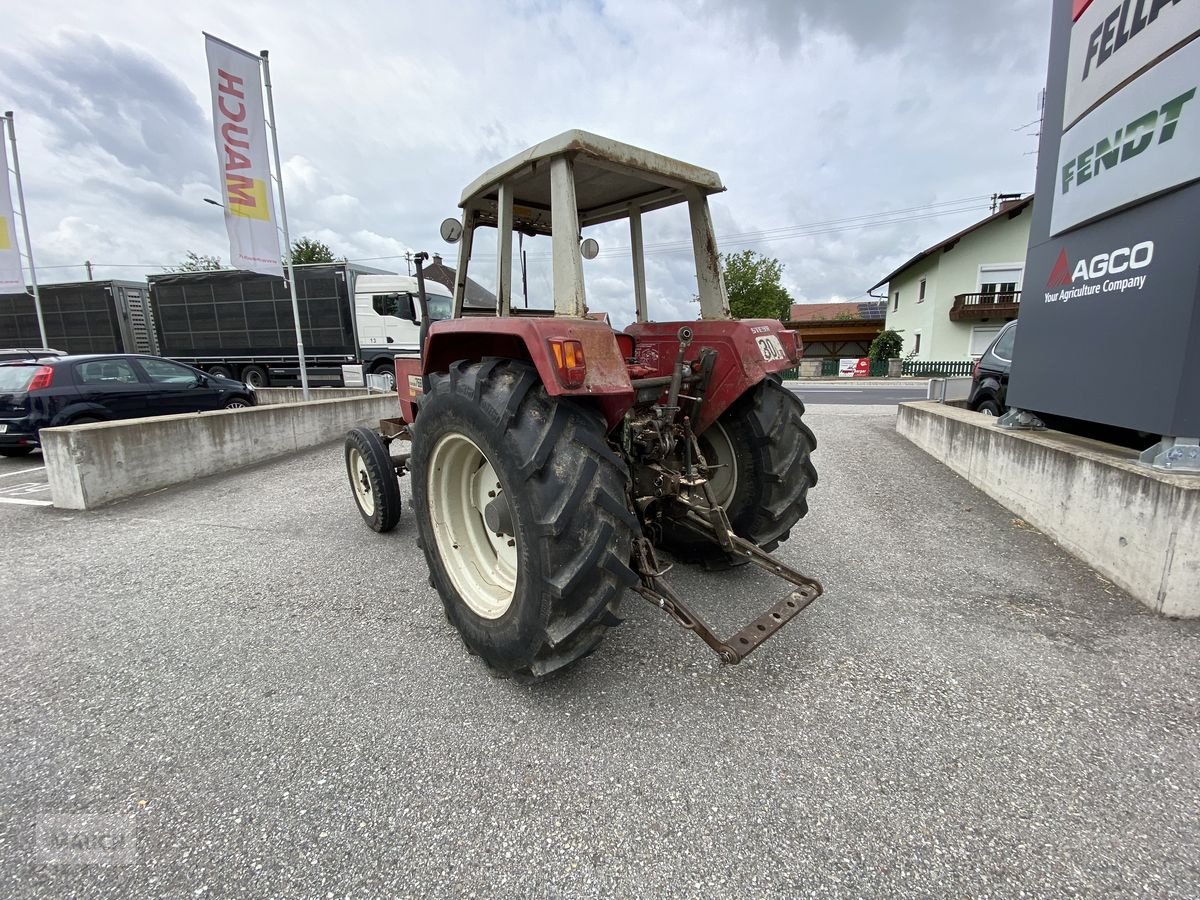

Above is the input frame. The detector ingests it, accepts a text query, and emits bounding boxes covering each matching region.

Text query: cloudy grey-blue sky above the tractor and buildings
[0,0,1050,322]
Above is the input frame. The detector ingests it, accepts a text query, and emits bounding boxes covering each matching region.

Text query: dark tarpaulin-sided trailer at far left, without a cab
[0,281,158,355]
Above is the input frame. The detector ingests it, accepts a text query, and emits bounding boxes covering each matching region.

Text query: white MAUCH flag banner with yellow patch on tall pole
[204,34,283,276]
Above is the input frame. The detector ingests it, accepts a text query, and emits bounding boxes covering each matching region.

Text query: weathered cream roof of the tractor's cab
[458,130,725,234]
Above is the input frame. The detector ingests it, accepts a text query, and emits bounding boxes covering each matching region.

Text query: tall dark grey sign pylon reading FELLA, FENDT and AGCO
[1008,0,1200,436]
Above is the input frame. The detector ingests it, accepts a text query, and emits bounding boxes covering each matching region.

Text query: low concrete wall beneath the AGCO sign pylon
[896,401,1200,618]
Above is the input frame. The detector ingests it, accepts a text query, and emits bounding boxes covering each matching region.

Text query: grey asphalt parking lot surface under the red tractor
[0,404,1200,898]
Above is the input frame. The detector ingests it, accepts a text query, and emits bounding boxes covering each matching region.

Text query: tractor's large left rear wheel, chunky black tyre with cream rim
[412,359,640,680]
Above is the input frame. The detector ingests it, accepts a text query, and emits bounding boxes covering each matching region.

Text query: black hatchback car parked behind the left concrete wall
[0,354,257,456]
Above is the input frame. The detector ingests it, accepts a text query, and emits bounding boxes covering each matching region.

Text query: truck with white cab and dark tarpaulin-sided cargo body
[149,263,465,388]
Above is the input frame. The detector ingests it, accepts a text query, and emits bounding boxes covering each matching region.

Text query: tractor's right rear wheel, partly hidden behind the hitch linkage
[662,378,817,564]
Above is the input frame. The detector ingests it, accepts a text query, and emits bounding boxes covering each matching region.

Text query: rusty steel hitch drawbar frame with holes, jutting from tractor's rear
[634,525,824,665]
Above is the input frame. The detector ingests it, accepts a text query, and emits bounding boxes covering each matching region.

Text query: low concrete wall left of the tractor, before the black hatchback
[41,394,400,509]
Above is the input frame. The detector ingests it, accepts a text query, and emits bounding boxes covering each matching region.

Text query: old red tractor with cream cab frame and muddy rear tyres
[346,131,821,678]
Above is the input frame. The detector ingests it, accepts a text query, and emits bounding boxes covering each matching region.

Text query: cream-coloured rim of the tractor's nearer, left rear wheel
[428,433,518,619]
